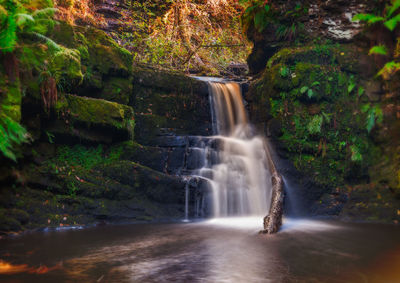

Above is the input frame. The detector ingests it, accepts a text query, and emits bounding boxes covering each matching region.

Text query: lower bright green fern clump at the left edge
[0,115,29,162]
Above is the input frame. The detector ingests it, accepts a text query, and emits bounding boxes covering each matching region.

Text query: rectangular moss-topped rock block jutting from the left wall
[49,95,135,143]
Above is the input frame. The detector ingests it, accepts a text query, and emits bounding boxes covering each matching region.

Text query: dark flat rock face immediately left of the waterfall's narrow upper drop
[131,68,212,147]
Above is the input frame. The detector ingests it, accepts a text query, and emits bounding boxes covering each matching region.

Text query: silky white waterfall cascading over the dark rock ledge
[190,80,275,217]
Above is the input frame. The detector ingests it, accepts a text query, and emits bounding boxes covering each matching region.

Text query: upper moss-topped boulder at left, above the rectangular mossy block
[50,22,132,104]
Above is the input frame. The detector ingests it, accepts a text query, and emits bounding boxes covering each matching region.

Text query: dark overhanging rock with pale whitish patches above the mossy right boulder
[247,0,372,73]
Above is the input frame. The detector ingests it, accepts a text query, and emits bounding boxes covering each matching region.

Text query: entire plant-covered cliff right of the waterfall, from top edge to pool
[246,1,400,223]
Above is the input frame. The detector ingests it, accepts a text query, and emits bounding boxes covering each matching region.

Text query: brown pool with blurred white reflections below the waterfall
[0,218,400,282]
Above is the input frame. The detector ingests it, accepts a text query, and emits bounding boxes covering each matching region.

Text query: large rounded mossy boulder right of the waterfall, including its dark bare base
[247,43,388,219]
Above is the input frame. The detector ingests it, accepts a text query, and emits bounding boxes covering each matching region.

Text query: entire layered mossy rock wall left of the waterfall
[0,22,211,235]
